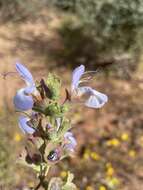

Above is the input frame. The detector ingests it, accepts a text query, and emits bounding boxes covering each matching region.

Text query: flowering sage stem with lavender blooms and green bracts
[13,63,108,190]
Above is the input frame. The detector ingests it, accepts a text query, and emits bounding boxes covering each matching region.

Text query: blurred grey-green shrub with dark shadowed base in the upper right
[53,0,143,75]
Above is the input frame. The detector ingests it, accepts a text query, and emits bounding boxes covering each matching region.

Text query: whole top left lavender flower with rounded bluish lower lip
[13,63,36,111]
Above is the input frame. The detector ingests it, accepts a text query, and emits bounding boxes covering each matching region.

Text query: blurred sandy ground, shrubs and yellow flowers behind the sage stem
[0,0,143,190]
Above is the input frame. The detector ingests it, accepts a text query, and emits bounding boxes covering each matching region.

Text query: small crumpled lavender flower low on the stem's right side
[63,132,77,152]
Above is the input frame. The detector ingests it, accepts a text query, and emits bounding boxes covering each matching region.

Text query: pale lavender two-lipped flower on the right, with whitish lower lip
[71,65,108,108]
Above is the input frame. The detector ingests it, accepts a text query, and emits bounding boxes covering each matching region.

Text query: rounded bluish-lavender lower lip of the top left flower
[13,88,34,111]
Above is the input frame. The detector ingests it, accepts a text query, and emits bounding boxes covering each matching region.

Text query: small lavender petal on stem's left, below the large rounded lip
[19,116,35,134]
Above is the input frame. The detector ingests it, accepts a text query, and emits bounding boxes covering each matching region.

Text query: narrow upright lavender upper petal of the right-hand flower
[71,65,85,91]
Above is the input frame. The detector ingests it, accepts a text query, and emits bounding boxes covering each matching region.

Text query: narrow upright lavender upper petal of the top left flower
[16,63,34,86]
